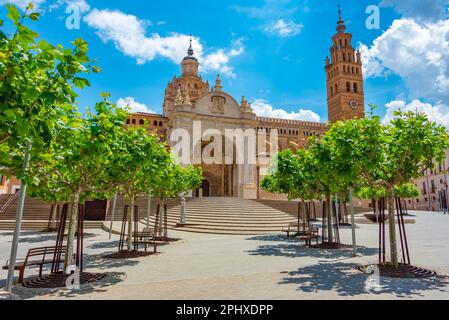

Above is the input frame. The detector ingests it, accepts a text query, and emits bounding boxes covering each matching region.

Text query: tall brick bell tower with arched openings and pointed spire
[326,8,365,123]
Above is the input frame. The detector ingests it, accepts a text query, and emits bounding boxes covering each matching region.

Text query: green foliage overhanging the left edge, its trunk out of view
[0,4,99,180]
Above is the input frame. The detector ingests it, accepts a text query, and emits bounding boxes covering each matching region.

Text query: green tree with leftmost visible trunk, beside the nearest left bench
[36,98,127,271]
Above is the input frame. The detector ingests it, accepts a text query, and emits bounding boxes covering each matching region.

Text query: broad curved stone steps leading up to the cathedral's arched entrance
[135,197,296,235]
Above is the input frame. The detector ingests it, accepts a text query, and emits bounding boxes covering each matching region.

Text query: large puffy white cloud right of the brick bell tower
[360,18,449,104]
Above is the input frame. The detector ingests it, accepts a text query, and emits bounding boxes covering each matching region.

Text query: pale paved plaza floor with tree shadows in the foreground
[0,212,449,299]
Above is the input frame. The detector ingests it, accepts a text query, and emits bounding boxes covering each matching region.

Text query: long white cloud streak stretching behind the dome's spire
[84,9,244,77]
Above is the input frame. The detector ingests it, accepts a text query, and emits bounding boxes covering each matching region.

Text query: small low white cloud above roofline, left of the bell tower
[252,99,320,122]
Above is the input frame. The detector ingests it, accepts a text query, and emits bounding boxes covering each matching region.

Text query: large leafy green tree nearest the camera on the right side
[329,111,449,268]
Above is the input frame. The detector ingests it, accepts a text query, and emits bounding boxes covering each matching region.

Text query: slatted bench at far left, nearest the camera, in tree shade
[2,247,66,283]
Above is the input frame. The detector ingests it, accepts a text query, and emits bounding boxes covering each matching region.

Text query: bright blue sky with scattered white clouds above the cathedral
[0,0,449,128]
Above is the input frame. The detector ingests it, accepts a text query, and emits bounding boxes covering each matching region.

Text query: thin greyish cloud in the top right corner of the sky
[380,0,449,21]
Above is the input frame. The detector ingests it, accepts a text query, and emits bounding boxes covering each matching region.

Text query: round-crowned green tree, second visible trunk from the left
[107,127,169,251]
